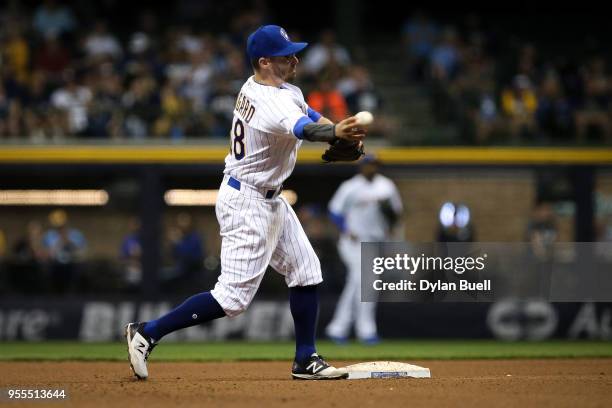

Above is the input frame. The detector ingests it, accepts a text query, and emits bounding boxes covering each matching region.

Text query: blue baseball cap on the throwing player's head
[247,25,308,59]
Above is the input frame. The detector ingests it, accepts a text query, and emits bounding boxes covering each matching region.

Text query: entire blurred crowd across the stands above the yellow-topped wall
[0,0,612,144]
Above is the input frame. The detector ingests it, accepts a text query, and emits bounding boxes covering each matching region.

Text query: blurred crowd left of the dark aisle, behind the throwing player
[0,0,384,142]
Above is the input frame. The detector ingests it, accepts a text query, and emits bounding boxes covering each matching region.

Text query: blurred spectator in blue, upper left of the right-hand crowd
[402,10,439,80]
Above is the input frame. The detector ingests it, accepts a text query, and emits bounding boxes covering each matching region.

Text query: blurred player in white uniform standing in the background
[326,155,402,344]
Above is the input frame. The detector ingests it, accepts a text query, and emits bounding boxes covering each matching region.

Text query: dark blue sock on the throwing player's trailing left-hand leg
[144,292,225,343]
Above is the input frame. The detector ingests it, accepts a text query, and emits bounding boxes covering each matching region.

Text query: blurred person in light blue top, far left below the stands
[43,210,87,293]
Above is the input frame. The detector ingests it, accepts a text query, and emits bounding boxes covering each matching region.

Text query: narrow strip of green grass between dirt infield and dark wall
[0,340,612,361]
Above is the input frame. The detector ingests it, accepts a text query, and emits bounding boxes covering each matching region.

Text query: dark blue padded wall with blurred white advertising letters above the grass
[0,298,612,342]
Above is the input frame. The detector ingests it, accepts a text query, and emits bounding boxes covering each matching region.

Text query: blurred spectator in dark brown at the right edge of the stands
[576,56,612,143]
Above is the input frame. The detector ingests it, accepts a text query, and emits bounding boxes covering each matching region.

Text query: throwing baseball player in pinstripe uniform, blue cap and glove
[126,25,366,380]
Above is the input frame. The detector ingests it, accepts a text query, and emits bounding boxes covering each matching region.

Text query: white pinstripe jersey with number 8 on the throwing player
[223,77,308,189]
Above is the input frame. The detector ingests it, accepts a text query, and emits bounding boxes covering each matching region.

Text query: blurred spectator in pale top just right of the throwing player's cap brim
[301,30,351,76]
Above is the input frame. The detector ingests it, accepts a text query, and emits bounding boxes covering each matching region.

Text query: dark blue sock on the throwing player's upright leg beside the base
[289,285,319,362]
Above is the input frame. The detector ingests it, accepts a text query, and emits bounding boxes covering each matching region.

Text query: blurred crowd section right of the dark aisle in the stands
[402,11,612,144]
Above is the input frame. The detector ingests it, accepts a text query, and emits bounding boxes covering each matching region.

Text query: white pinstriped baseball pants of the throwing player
[211,176,323,316]
